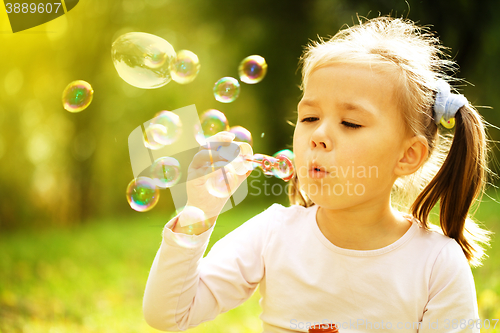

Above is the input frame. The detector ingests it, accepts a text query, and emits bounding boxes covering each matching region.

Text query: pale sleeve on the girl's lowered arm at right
[419,239,479,333]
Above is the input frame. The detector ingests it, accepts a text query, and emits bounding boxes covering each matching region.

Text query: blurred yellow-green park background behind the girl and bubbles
[0,0,500,333]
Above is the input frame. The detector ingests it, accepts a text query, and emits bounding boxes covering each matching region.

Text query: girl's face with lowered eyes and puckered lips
[293,64,405,209]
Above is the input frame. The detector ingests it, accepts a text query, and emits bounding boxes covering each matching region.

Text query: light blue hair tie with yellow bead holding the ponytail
[434,79,468,128]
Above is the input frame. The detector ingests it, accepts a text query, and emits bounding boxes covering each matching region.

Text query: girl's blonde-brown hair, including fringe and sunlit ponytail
[289,17,491,266]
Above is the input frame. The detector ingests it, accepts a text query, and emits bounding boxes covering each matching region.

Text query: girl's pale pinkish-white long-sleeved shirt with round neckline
[143,204,479,333]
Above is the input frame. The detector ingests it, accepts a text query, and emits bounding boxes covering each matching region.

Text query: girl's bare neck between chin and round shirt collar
[316,206,411,250]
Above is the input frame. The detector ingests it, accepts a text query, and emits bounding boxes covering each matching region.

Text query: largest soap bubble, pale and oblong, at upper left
[111,32,176,89]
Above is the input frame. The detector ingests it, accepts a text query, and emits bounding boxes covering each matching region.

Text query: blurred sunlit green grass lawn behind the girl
[0,192,500,333]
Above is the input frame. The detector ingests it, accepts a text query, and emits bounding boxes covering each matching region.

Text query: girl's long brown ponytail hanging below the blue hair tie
[410,105,491,266]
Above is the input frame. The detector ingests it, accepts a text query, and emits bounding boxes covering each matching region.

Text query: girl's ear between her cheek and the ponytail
[394,135,429,177]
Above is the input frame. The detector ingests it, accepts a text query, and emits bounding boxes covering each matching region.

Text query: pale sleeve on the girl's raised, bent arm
[143,205,276,331]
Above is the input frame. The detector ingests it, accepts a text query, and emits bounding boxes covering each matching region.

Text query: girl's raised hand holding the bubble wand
[177,132,251,229]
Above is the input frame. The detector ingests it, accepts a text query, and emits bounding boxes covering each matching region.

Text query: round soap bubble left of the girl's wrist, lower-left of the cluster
[127,177,160,212]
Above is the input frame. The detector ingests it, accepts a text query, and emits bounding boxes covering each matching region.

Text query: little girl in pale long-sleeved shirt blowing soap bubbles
[143,17,489,332]
